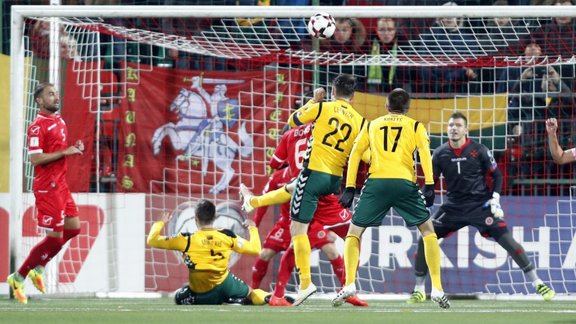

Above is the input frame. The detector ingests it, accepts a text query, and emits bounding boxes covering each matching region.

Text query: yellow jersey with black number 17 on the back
[346,114,434,187]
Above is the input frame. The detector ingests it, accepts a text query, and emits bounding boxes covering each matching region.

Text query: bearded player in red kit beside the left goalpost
[7,83,84,304]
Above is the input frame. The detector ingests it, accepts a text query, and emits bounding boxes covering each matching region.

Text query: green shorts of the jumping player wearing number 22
[290,169,342,224]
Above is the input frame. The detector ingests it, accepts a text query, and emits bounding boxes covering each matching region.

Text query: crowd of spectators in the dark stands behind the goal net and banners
[2,0,576,194]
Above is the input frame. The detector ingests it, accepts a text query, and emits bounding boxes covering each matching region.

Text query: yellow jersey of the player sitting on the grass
[147,222,261,293]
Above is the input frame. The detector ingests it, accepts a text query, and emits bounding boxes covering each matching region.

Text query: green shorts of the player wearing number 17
[352,178,430,227]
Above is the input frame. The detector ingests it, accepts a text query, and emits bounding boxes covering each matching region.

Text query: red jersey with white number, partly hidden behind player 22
[270,124,312,177]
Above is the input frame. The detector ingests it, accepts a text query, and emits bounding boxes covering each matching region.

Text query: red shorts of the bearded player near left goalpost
[34,187,78,232]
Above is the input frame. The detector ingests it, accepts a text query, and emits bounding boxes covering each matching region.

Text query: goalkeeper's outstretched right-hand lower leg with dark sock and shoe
[484,219,556,301]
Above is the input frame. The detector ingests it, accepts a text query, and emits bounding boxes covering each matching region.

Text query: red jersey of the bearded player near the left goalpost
[28,113,68,190]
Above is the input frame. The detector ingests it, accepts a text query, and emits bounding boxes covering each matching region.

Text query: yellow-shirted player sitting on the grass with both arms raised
[146,199,269,305]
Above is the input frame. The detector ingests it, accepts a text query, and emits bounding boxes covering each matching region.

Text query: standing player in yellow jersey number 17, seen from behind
[332,88,450,308]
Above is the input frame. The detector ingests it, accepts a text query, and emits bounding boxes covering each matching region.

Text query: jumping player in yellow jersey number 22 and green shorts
[288,74,365,306]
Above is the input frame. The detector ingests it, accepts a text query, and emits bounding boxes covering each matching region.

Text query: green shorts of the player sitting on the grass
[194,272,250,305]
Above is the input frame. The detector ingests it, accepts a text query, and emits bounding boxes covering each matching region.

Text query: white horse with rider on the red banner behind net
[152,77,254,194]
